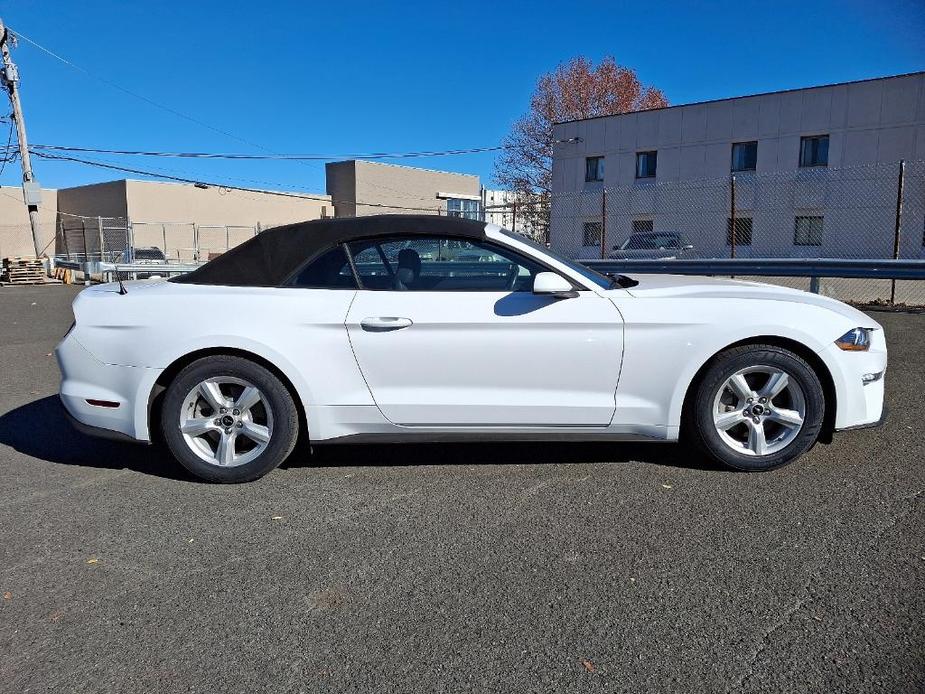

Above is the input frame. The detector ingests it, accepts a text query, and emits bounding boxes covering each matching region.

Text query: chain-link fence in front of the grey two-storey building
[549,161,925,306]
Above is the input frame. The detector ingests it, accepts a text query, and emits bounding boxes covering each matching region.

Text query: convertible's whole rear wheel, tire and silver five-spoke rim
[161,355,299,482]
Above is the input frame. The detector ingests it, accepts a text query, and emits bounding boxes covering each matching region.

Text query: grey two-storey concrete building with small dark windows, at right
[550,72,925,257]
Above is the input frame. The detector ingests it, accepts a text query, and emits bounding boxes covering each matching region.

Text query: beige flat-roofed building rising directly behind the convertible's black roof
[325,160,481,219]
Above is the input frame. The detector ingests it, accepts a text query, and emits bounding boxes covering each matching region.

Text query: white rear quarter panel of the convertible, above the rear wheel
[74,282,373,424]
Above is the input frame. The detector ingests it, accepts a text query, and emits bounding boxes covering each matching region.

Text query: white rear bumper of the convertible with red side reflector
[55,332,161,441]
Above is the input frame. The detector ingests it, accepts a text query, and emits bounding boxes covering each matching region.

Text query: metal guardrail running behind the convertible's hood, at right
[579,258,925,280]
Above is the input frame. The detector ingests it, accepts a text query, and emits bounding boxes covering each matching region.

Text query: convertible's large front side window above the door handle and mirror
[350,237,545,292]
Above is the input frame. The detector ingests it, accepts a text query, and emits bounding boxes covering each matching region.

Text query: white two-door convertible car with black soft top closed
[57,215,887,482]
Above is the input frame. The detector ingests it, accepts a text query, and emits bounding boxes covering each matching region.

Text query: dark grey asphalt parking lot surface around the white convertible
[0,287,925,694]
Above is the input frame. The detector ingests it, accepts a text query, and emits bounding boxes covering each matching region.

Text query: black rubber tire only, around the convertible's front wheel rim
[682,345,825,472]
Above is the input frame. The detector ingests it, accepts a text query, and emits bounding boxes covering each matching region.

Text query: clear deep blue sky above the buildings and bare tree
[0,0,925,192]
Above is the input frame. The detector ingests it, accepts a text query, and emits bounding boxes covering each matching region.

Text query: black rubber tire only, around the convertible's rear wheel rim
[161,355,299,483]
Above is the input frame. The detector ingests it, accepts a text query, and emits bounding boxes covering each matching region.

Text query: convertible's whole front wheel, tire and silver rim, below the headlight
[684,345,825,471]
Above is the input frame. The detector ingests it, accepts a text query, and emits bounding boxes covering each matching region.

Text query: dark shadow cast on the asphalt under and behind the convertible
[0,396,720,481]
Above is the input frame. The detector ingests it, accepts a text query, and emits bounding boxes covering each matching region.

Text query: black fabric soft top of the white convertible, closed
[170,214,485,287]
